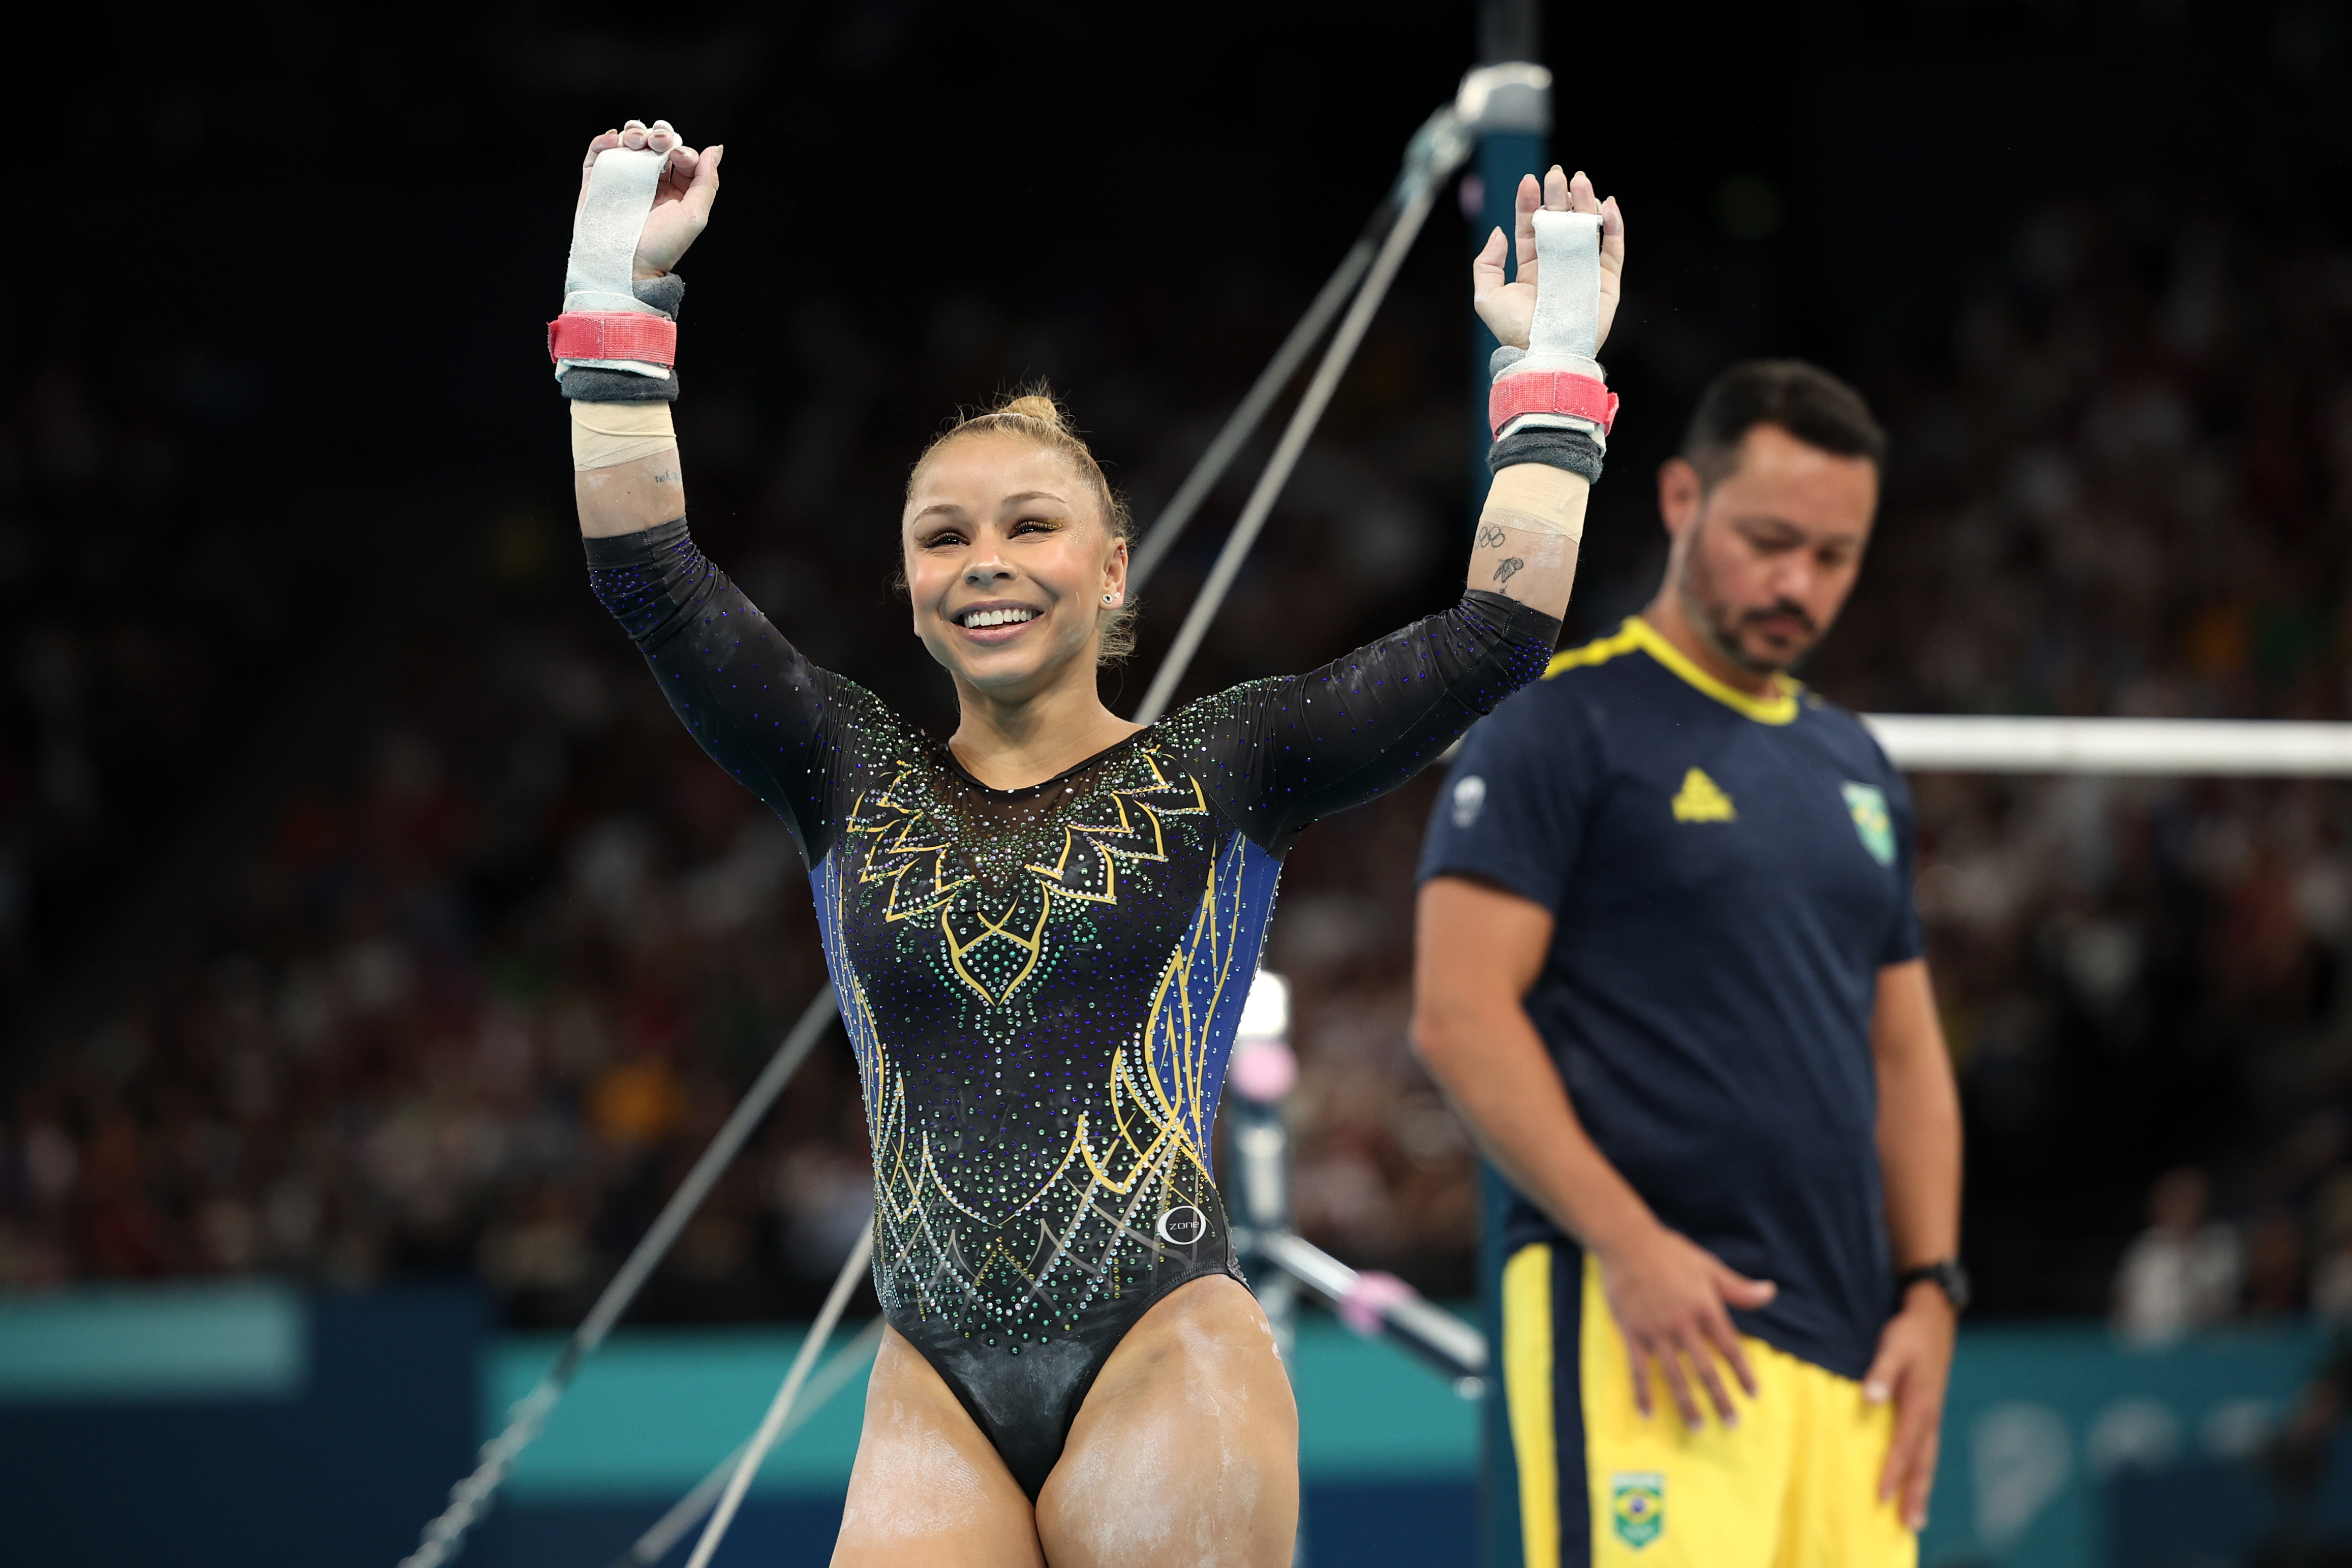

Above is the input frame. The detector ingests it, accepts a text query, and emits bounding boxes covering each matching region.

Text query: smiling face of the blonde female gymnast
[901,433,1126,703]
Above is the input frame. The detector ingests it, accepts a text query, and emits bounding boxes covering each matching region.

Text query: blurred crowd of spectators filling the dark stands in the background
[14,190,2352,1338]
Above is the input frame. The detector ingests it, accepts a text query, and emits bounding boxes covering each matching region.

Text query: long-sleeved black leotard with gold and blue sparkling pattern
[588,519,1560,1497]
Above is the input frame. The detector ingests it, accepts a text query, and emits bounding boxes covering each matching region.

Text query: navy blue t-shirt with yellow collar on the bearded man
[1421,618,1919,1377]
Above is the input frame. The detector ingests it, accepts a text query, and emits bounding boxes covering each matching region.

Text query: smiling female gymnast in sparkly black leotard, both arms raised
[560,120,1623,1568]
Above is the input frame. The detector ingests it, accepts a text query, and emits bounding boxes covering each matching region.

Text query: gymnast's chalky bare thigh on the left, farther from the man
[833,1328,1044,1568]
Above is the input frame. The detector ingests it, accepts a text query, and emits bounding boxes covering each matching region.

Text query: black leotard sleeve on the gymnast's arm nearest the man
[1167,588,1560,853]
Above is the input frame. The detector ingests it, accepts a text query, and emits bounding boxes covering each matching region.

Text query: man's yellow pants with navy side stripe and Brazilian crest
[1503,1246,1919,1568]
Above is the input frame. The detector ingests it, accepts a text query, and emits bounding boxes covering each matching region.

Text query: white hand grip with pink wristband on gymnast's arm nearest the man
[1486,209,1616,449]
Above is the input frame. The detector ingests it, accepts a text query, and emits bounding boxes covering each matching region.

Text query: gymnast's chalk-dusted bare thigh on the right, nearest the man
[1037,1274,1298,1568]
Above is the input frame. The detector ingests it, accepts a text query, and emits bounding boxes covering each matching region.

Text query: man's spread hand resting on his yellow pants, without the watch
[1595,1225,1778,1427]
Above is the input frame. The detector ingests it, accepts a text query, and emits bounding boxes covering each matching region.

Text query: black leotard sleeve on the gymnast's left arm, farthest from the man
[583,517,896,865]
